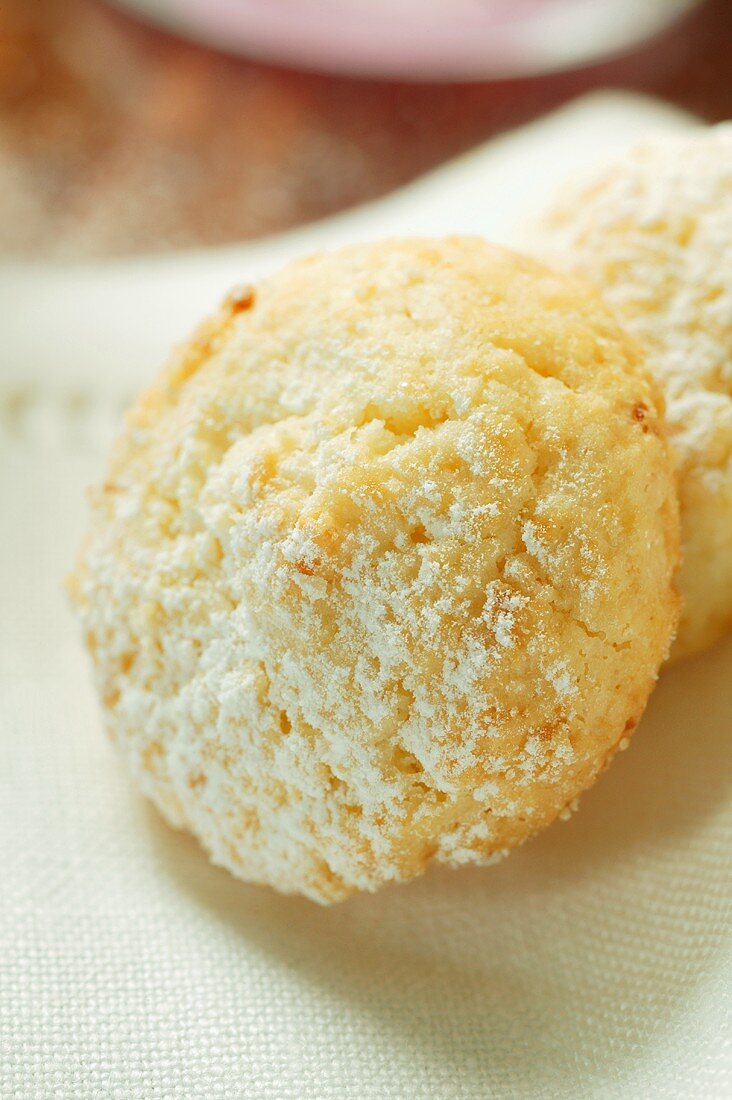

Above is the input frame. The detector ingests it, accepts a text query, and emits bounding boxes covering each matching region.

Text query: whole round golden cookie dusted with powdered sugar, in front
[72,239,678,902]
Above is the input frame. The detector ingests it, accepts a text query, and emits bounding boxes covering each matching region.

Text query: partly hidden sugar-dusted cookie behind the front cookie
[532,123,732,657]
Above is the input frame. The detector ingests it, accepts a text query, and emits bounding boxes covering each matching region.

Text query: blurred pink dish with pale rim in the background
[114,0,699,79]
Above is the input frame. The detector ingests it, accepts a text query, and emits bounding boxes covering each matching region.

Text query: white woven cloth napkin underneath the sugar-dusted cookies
[0,99,732,1100]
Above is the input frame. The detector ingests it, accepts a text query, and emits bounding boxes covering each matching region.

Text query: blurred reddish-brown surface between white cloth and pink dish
[0,0,732,259]
